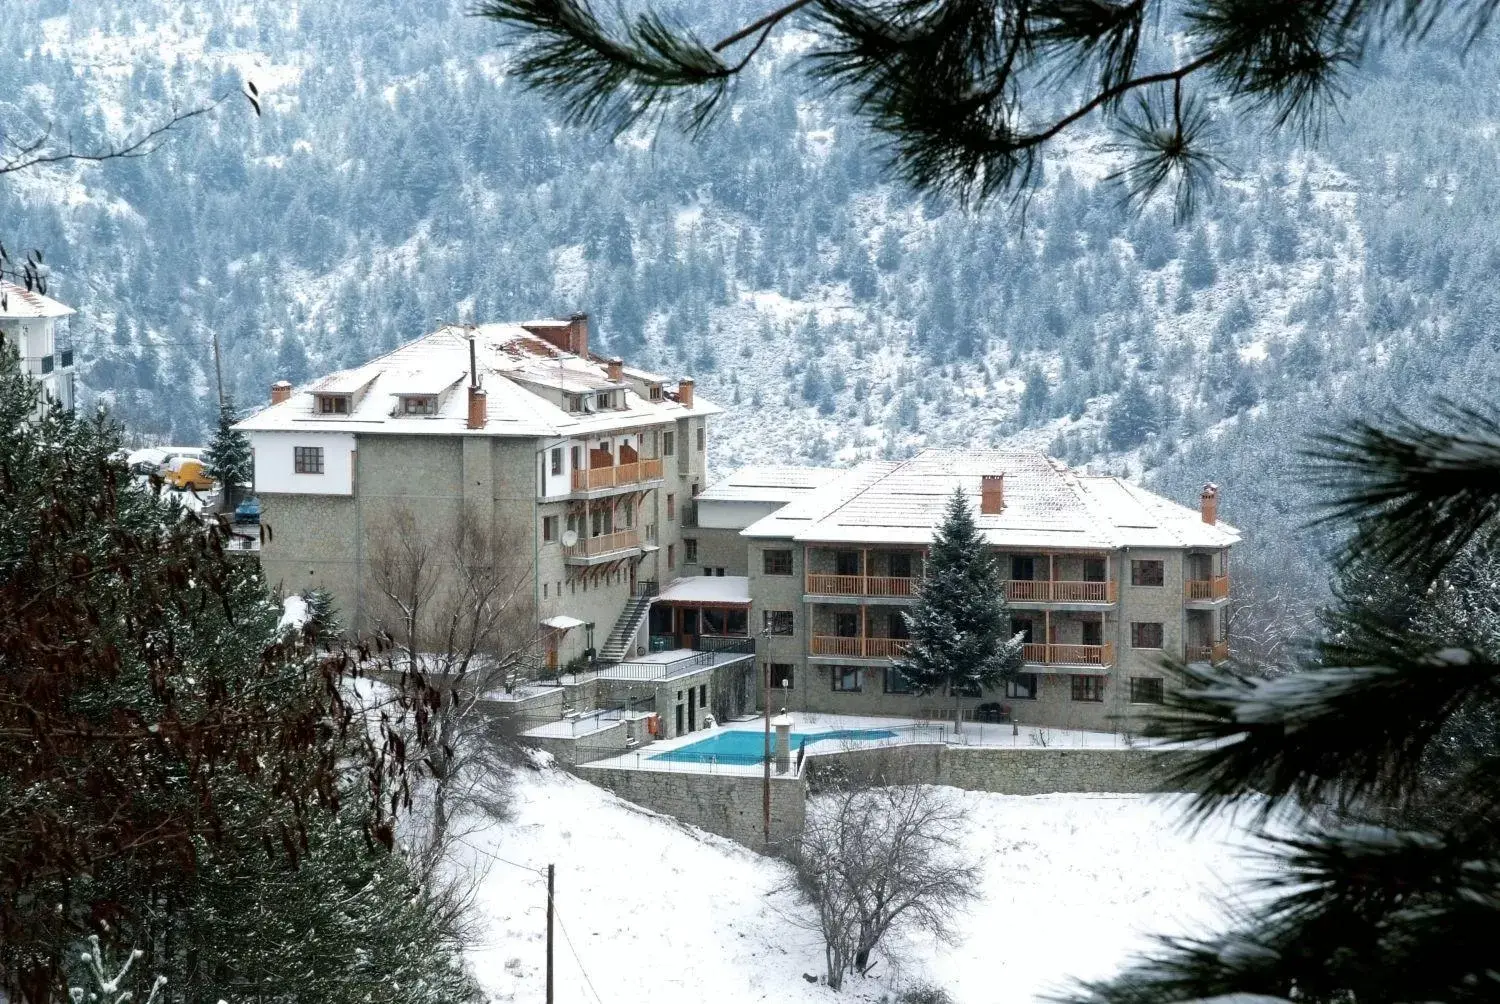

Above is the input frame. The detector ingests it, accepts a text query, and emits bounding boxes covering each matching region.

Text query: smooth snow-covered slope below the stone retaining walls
[465,770,1250,1004]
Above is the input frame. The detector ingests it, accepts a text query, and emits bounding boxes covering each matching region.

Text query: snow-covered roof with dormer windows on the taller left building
[237,321,723,437]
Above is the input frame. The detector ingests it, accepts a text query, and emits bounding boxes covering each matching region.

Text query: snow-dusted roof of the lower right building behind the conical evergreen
[744,450,1239,551]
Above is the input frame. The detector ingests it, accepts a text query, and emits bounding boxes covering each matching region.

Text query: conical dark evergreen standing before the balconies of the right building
[893,488,1022,731]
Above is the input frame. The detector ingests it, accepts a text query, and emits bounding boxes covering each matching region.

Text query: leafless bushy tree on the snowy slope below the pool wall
[794,780,978,990]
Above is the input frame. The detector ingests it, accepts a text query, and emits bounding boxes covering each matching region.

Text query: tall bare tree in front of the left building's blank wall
[371,507,539,878]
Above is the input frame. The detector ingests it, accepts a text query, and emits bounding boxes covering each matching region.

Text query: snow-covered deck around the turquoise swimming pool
[579,711,1149,777]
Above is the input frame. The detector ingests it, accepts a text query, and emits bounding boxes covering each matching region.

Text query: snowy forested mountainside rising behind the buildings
[0,0,1500,618]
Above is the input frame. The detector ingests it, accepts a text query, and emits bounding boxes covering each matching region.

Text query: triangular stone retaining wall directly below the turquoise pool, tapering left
[578,767,807,851]
